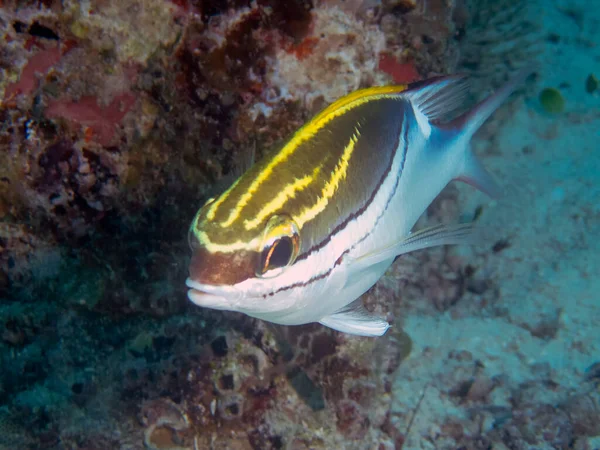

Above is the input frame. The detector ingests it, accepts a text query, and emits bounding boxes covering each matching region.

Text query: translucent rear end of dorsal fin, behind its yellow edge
[406,74,469,122]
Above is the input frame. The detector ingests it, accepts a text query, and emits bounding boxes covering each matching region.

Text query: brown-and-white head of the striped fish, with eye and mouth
[186,195,312,317]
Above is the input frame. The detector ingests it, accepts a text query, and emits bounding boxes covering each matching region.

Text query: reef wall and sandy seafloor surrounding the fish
[0,0,600,450]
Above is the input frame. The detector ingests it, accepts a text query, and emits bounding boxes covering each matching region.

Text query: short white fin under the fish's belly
[319,299,390,337]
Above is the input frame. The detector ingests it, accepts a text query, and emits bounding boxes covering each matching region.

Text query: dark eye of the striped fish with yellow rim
[256,215,300,278]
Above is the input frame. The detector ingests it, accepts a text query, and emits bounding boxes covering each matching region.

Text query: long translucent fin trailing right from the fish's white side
[349,222,483,271]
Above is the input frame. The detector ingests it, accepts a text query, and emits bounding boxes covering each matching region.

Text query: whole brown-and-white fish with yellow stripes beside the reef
[186,70,529,337]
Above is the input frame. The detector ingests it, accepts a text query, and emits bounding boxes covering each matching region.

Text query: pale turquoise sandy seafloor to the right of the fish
[394,0,600,448]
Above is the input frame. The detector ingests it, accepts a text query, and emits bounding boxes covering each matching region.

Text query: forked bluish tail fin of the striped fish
[437,69,532,198]
